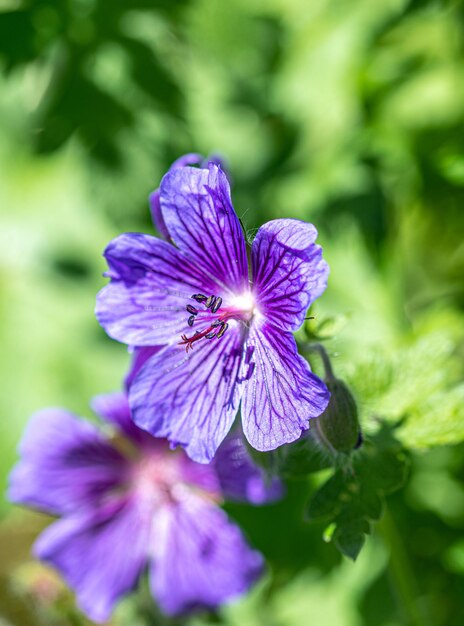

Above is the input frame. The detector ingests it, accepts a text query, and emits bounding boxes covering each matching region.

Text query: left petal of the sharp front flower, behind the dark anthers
[95,233,220,346]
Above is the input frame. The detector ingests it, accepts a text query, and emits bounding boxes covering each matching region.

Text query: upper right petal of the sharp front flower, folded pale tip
[251,219,329,330]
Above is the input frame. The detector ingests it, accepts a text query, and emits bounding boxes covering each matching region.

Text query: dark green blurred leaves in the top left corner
[0,0,187,166]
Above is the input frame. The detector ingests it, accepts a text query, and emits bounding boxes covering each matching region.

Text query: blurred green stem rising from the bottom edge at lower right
[378,508,431,626]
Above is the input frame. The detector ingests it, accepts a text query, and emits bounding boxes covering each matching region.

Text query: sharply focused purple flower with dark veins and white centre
[96,158,329,463]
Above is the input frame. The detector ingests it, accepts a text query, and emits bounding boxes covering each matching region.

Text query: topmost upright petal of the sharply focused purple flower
[160,163,248,296]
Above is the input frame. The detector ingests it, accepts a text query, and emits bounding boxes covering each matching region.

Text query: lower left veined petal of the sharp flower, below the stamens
[129,321,243,463]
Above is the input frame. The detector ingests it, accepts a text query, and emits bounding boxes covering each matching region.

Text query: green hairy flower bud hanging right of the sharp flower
[315,377,362,453]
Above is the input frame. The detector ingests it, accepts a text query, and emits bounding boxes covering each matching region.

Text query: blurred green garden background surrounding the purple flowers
[0,0,464,626]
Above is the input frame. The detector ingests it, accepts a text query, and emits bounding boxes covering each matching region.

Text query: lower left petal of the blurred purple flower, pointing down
[34,499,152,622]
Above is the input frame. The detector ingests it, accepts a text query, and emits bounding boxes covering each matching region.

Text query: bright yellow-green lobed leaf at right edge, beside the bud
[345,327,464,448]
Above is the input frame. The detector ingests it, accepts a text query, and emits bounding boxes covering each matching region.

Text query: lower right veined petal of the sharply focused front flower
[242,322,329,451]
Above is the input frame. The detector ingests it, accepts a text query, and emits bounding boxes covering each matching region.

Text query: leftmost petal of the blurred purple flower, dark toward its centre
[8,409,127,514]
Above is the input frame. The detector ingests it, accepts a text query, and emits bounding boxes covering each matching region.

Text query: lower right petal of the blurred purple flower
[150,496,263,615]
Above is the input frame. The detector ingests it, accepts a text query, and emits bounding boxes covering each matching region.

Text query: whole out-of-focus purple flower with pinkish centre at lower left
[9,394,281,621]
